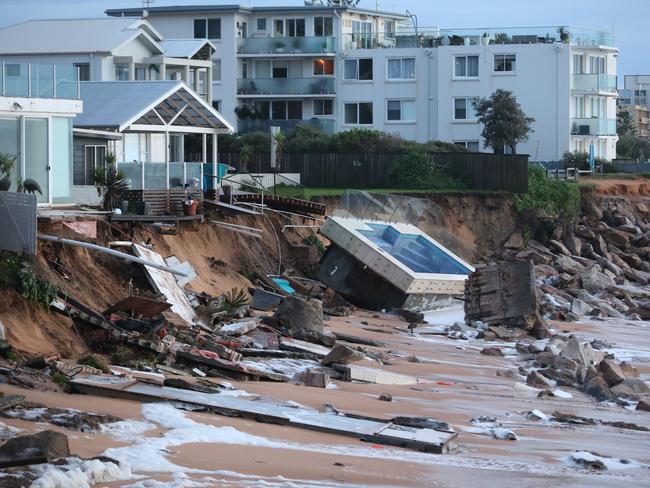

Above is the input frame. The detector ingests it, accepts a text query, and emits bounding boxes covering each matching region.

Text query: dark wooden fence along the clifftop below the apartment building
[219,152,528,193]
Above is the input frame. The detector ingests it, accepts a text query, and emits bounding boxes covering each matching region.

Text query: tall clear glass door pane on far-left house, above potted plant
[25,118,50,203]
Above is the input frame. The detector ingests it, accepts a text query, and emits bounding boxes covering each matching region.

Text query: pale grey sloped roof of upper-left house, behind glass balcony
[0,17,162,54]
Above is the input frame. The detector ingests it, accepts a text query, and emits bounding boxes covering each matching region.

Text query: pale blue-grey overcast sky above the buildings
[0,0,650,76]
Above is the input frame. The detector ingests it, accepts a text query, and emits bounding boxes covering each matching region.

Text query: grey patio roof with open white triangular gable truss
[73,81,233,132]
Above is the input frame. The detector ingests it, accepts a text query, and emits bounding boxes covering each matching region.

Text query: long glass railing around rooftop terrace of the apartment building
[342,26,614,50]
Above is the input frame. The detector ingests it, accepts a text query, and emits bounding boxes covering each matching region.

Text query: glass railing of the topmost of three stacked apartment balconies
[237,37,336,56]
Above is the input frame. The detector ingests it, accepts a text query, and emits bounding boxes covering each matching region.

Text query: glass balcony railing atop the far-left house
[0,62,79,100]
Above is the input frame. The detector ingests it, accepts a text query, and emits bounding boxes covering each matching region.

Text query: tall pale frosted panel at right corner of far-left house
[52,117,72,203]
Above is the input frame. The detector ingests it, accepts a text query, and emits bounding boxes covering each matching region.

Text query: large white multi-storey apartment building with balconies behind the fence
[107,5,618,160]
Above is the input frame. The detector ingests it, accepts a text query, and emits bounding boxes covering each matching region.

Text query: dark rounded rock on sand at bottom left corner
[0,430,70,466]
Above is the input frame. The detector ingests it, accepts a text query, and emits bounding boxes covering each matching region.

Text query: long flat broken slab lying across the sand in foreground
[71,376,458,454]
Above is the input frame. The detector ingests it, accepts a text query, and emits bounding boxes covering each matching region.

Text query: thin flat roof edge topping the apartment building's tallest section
[105,4,407,18]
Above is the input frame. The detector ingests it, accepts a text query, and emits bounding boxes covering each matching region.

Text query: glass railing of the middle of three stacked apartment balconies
[237,77,336,95]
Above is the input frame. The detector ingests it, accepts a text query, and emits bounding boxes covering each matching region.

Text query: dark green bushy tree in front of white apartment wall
[474,89,535,154]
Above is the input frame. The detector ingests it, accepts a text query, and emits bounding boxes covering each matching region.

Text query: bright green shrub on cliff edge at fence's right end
[514,167,580,221]
